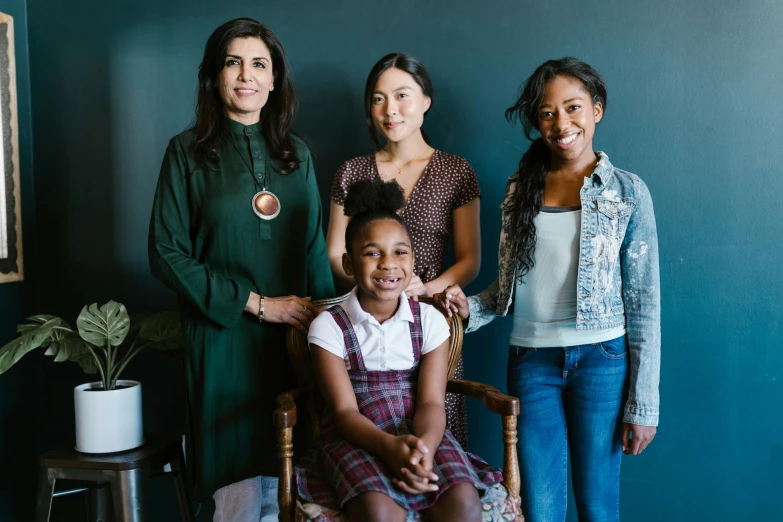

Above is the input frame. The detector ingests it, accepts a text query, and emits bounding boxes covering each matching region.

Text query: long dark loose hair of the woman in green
[193,18,299,174]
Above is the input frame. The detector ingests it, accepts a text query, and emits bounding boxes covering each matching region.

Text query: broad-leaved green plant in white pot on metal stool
[0,301,183,453]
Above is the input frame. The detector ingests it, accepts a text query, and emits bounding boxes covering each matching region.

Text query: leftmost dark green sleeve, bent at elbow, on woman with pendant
[148,139,253,328]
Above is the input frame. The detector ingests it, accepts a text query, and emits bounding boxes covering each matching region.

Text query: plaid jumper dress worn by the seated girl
[296,301,503,511]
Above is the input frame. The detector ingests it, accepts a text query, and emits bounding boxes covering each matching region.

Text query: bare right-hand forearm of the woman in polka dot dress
[424,198,481,296]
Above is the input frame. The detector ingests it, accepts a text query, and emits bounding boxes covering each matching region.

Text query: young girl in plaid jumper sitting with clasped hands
[296,180,502,522]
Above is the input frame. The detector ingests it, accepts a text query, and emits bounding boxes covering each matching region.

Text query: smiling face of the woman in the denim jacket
[537,76,604,166]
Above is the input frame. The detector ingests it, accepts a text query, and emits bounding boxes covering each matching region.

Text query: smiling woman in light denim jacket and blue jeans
[436,58,660,522]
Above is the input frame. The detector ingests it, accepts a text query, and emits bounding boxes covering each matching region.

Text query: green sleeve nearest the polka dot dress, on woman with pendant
[305,151,336,299]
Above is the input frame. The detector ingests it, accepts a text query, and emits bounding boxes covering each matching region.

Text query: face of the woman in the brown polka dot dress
[370,67,432,142]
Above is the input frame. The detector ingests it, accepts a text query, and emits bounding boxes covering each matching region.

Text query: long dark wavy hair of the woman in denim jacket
[506,57,606,281]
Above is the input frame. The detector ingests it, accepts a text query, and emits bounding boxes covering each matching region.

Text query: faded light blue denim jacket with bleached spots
[465,152,661,426]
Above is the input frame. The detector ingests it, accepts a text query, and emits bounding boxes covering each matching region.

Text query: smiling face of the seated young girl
[343,219,413,304]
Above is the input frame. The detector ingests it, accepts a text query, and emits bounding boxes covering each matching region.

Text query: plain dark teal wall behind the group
[0,0,783,522]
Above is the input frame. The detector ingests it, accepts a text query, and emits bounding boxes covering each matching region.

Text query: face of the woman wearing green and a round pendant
[218,37,275,125]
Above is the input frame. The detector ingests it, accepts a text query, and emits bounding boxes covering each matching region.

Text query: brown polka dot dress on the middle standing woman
[331,150,481,449]
